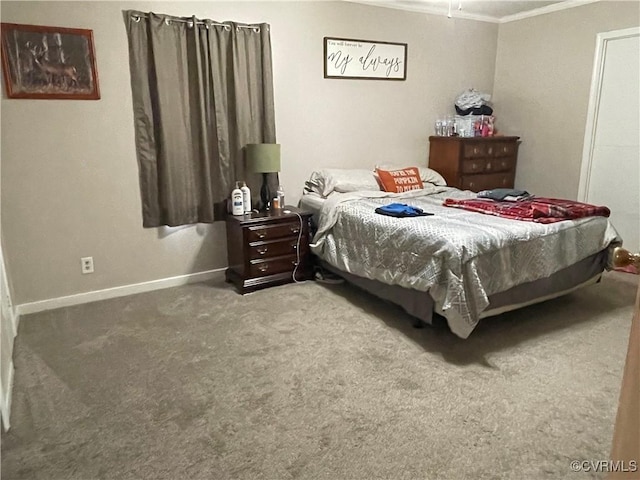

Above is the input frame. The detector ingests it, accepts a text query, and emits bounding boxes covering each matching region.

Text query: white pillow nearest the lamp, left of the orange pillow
[305,168,380,197]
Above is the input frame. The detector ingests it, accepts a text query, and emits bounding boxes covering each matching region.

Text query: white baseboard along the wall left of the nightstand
[16,268,226,315]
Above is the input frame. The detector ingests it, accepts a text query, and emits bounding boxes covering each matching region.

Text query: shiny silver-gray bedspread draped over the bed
[311,184,621,338]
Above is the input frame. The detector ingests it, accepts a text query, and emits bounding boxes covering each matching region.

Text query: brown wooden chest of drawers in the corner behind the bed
[429,137,520,192]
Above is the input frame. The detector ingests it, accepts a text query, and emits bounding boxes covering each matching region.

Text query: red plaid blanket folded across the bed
[443,197,611,223]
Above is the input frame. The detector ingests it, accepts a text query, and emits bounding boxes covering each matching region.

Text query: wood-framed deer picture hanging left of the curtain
[0,23,100,100]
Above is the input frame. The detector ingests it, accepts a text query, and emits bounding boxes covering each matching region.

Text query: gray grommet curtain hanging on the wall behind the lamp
[123,10,277,227]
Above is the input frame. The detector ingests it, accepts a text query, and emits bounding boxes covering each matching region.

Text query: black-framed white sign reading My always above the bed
[324,37,407,80]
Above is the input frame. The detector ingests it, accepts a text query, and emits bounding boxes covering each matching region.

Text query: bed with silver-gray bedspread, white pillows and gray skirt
[300,168,621,338]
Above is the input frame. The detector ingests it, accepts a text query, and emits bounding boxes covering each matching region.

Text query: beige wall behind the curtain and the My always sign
[1,1,498,305]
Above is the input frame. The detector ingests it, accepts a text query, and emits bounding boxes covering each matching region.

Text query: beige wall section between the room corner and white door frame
[493,1,640,199]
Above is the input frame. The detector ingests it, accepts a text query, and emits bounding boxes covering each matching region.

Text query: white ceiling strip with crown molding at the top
[348,0,597,23]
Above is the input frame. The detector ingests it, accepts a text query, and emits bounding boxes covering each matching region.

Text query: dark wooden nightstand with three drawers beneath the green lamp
[225,206,313,294]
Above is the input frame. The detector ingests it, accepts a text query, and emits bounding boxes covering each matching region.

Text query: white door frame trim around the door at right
[578,27,640,202]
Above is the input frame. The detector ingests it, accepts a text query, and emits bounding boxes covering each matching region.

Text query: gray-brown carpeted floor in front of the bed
[2,273,637,480]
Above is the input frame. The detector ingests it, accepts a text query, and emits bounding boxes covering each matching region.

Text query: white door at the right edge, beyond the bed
[578,28,640,252]
